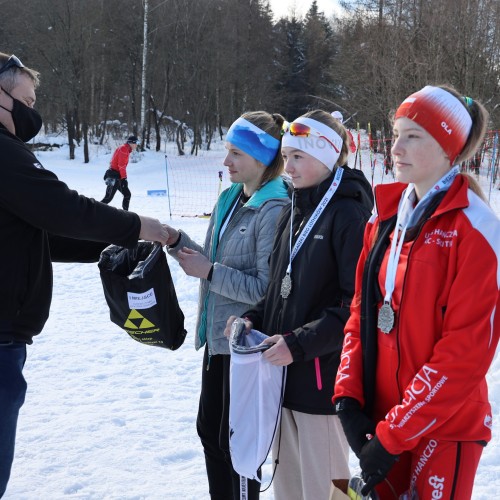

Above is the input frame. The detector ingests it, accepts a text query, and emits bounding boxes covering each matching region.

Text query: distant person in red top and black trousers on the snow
[101,135,139,210]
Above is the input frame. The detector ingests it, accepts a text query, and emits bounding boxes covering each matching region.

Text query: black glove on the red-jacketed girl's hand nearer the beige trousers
[335,398,376,458]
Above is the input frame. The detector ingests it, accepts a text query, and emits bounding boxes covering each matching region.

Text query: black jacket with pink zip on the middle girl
[243,167,373,415]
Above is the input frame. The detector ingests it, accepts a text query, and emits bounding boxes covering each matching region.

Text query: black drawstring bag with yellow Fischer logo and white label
[98,241,186,351]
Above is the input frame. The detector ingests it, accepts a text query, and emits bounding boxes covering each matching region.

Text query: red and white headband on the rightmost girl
[394,85,472,165]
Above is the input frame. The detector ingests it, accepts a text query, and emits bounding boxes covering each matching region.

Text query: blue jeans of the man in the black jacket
[0,342,27,497]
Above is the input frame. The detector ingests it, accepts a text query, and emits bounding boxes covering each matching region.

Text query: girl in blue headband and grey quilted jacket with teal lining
[167,111,290,499]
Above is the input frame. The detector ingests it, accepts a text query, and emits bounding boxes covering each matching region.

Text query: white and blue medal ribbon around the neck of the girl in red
[384,165,459,307]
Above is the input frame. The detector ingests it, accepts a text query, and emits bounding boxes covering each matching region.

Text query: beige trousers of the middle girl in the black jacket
[273,408,350,500]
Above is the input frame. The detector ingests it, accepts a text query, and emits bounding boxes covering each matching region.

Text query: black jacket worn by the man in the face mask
[0,125,141,343]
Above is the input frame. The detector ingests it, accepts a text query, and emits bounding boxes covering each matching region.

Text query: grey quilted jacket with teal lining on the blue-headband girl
[168,178,290,355]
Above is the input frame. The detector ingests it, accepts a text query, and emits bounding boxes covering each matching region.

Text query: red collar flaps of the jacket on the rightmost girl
[375,174,469,221]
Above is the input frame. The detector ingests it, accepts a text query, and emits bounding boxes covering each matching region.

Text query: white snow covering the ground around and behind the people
[4,138,500,500]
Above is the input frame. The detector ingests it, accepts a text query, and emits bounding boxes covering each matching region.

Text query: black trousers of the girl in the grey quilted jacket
[196,347,261,500]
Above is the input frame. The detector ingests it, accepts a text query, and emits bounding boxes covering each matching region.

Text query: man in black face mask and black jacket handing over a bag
[0,52,168,497]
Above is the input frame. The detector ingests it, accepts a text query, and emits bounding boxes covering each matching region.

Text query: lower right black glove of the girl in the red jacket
[359,436,399,495]
